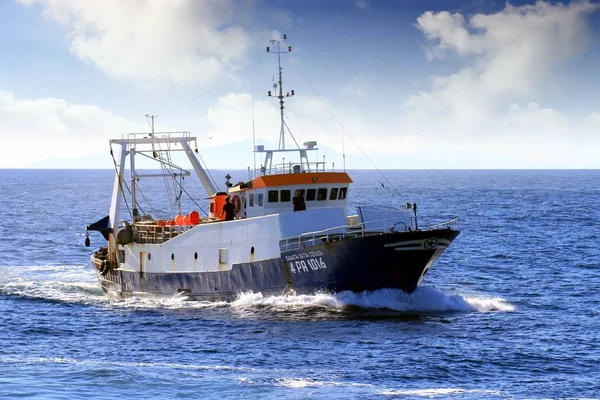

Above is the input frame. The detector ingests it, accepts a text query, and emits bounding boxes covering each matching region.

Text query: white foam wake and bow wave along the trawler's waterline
[0,265,515,313]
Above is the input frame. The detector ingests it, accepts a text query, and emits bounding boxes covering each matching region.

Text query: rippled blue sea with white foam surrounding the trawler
[0,170,600,399]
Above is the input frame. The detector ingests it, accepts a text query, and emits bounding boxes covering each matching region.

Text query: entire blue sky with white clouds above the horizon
[0,0,600,169]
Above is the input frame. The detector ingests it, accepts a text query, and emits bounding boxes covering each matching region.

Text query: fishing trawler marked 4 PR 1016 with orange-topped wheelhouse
[86,36,459,301]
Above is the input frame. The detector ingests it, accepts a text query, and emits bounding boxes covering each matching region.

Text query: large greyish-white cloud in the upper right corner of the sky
[406,1,600,128]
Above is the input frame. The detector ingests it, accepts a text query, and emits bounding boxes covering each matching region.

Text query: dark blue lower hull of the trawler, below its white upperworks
[96,229,459,301]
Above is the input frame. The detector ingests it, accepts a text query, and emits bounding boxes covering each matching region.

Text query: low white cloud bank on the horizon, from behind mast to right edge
[202,86,600,168]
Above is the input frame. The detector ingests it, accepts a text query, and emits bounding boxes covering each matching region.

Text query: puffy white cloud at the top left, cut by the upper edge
[18,0,251,84]
